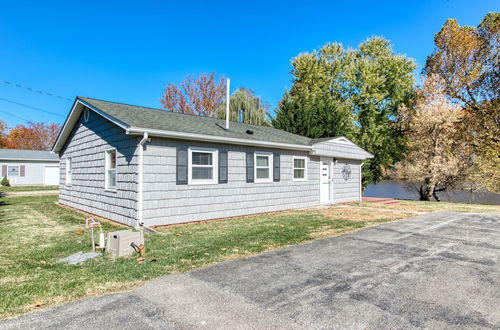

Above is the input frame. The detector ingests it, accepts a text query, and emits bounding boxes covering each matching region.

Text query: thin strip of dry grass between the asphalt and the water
[351,200,500,213]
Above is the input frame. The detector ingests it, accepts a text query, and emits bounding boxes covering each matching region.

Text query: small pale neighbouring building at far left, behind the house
[0,149,59,186]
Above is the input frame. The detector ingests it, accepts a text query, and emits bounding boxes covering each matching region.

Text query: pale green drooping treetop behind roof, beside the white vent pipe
[216,88,269,125]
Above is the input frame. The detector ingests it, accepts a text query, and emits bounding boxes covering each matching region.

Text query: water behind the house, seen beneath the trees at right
[363,181,500,205]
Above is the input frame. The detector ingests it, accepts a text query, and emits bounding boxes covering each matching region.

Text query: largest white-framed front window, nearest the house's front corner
[189,149,217,184]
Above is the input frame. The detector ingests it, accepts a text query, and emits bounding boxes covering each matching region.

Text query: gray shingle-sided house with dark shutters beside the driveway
[53,97,372,226]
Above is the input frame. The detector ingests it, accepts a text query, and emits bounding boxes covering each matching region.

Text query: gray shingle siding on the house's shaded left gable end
[59,112,138,225]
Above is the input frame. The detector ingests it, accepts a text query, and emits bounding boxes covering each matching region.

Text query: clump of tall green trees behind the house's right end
[273,37,416,185]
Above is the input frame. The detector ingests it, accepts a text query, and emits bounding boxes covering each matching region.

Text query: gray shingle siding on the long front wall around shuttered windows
[144,138,319,225]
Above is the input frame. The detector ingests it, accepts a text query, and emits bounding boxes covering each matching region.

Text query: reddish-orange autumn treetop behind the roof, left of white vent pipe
[160,73,226,117]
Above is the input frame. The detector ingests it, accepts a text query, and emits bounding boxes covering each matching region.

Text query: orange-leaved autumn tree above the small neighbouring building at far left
[0,122,61,150]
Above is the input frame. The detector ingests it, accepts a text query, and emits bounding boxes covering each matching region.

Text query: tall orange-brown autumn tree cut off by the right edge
[424,13,500,193]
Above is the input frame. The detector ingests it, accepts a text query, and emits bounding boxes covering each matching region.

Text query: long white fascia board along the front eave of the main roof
[127,127,312,151]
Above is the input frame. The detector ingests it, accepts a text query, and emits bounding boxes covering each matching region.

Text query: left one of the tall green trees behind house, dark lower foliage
[272,43,355,138]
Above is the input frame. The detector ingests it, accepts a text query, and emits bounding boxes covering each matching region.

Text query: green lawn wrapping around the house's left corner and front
[0,196,409,319]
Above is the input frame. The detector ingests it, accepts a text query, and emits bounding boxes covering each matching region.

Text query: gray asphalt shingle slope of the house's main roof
[78,97,312,145]
